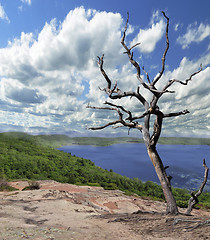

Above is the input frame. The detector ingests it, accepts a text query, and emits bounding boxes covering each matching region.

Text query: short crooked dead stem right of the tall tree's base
[186,159,209,215]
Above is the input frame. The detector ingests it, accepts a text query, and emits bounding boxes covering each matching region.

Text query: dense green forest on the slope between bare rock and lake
[0,133,210,209]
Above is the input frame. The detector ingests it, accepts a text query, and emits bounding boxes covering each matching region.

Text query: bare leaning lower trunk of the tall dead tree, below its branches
[147,146,178,214]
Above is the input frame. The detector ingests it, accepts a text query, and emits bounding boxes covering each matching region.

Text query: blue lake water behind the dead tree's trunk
[59,143,210,191]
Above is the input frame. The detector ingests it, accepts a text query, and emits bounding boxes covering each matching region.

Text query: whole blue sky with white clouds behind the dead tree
[0,0,210,137]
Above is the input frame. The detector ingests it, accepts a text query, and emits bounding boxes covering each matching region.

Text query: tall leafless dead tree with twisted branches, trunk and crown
[87,12,202,214]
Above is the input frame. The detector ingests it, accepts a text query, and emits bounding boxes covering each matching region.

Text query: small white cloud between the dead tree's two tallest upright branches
[131,11,166,53]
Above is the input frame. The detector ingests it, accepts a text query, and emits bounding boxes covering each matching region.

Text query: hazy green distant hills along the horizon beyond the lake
[0,132,210,148]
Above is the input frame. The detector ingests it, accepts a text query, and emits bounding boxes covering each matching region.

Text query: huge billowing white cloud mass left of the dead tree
[0,7,124,133]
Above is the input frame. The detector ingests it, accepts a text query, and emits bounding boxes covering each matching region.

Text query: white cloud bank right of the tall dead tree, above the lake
[159,54,210,137]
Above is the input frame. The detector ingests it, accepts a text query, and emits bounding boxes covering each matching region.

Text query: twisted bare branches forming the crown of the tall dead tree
[89,12,202,144]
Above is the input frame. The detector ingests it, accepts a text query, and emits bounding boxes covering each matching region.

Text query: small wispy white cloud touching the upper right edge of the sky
[177,23,210,49]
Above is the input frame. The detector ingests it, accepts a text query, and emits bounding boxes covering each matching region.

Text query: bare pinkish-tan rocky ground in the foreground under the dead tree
[0,181,210,240]
